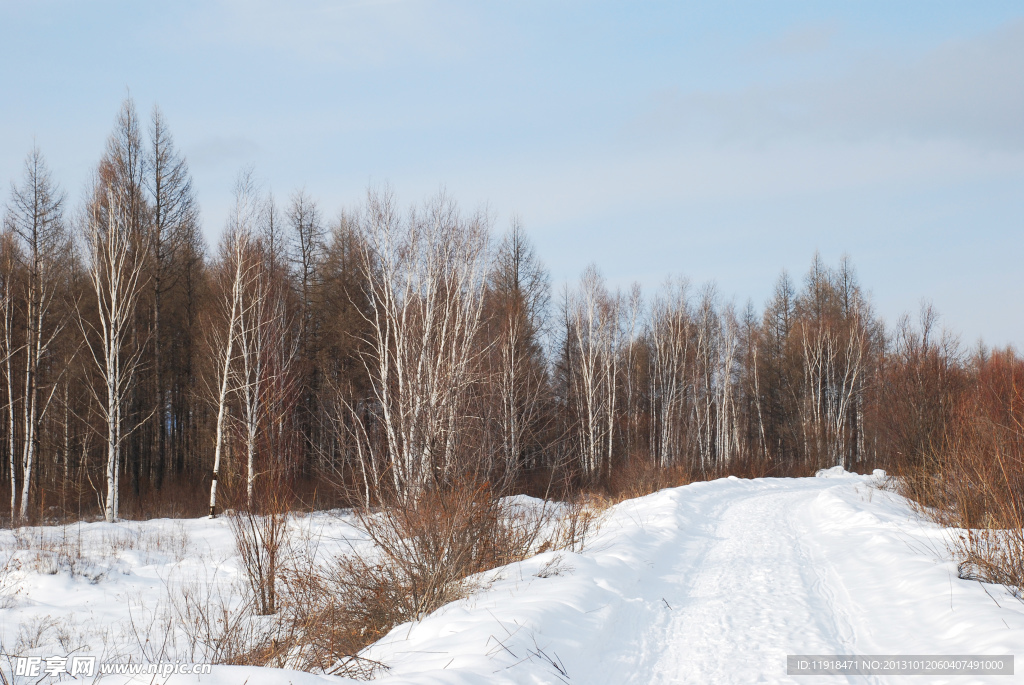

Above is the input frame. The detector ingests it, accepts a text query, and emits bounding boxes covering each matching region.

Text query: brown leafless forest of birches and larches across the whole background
[0,101,1024,521]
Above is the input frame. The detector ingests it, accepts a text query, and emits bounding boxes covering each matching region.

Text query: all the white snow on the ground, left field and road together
[0,472,1024,685]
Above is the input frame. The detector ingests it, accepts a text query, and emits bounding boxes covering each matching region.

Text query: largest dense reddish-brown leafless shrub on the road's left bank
[272,481,545,677]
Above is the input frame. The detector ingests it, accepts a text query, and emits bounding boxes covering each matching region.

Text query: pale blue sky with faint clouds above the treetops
[0,0,1024,346]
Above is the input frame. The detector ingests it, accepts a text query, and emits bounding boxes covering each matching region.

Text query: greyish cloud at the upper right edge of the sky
[637,22,1024,148]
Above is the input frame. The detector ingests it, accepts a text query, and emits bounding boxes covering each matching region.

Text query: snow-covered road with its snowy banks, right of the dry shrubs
[364,476,1024,685]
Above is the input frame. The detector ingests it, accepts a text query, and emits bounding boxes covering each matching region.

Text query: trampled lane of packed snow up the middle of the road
[606,483,863,685]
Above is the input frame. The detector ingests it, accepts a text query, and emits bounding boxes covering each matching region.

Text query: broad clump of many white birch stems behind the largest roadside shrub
[356,192,487,499]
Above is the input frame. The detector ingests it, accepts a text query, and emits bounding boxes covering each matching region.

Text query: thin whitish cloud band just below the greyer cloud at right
[458,140,1024,232]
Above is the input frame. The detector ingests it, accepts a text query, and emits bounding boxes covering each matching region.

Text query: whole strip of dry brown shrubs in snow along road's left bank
[132,480,598,679]
